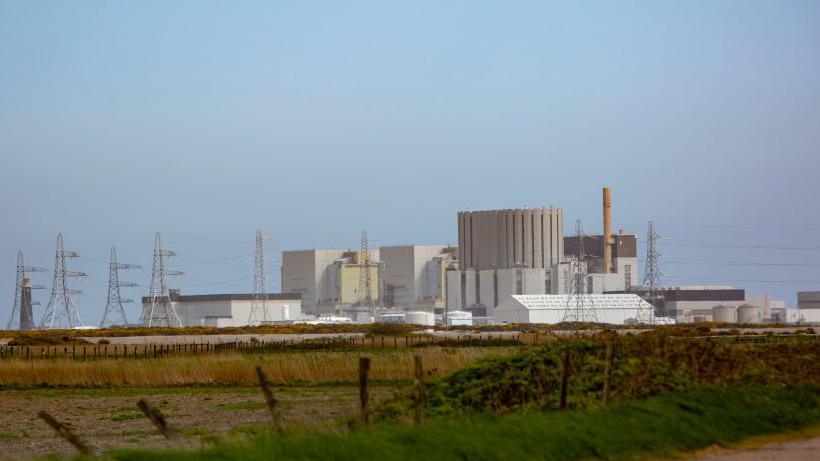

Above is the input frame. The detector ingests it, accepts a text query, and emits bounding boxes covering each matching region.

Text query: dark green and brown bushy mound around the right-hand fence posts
[379,332,820,419]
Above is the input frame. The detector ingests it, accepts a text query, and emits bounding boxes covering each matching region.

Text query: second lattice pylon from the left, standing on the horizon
[40,234,85,328]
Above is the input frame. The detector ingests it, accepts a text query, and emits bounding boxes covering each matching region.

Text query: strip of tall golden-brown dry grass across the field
[0,347,516,387]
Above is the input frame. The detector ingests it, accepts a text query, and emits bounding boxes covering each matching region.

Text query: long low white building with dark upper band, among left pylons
[142,293,302,327]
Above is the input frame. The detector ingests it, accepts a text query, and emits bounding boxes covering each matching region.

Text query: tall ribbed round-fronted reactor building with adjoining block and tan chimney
[447,188,638,320]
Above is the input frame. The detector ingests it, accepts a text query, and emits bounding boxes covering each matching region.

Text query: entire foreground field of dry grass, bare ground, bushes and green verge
[0,331,820,460]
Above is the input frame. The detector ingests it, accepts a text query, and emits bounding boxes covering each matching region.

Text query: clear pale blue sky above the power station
[0,0,820,326]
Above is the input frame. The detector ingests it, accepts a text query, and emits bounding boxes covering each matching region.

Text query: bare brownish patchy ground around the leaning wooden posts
[0,384,399,461]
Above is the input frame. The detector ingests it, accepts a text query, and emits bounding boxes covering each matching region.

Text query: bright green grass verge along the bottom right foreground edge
[93,385,820,461]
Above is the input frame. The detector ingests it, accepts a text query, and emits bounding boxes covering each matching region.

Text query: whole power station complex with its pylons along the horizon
[7,188,820,329]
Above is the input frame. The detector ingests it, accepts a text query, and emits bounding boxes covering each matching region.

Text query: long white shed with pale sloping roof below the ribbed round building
[495,294,669,325]
